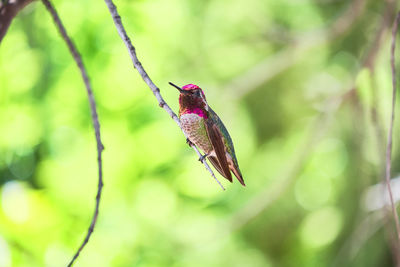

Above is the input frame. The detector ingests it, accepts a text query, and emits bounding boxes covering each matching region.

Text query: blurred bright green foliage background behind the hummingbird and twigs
[0,0,400,267]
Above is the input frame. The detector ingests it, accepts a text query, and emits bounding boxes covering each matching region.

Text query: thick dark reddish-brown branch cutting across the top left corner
[0,0,33,43]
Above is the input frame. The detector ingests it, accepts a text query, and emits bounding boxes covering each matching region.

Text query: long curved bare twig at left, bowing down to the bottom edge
[42,0,104,266]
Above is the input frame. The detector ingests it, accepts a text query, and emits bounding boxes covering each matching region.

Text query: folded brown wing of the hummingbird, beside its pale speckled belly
[206,121,232,181]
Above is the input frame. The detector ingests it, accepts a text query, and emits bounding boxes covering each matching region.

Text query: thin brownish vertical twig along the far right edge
[386,9,400,249]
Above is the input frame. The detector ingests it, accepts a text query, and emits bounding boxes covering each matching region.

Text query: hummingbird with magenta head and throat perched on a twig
[169,82,246,186]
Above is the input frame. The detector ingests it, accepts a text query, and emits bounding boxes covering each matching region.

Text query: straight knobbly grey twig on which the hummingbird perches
[104,0,225,190]
